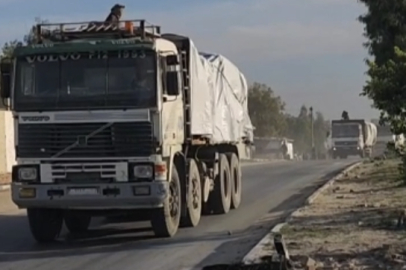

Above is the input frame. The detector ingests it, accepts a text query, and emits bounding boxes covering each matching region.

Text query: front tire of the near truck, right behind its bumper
[151,165,181,237]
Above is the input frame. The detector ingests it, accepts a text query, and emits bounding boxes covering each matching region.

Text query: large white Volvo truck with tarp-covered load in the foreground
[1,20,253,243]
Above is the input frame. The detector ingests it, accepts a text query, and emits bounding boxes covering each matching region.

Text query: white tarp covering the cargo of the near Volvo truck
[190,41,253,143]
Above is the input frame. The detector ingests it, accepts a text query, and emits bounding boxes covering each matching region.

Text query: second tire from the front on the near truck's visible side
[181,159,202,227]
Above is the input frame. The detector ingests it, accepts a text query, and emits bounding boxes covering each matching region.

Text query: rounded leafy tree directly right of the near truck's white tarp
[248,83,286,137]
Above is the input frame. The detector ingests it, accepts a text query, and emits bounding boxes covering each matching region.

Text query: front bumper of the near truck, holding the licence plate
[11,181,169,210]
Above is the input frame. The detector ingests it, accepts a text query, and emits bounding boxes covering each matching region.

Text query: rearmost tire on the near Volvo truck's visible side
[227,153,242,209]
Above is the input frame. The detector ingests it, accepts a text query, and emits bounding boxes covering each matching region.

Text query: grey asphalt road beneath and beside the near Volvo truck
[0,159,355,270]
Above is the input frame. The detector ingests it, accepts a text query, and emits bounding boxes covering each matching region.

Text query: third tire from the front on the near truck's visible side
[209,154,231,214]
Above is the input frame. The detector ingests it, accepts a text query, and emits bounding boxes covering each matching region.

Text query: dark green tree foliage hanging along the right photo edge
[359,0,406,177]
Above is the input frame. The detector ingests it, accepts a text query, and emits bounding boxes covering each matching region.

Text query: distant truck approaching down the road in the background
[331,119,377,158]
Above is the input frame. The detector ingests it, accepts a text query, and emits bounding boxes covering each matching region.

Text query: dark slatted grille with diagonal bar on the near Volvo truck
[16,122,155,158]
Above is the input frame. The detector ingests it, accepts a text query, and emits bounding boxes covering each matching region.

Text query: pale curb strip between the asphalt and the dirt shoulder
[242,161,363,264]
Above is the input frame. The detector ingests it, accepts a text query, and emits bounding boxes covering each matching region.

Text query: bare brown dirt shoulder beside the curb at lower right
[281,160,406,270]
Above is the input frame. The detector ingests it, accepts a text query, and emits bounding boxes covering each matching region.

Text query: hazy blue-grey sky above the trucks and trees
[0,0,378,119]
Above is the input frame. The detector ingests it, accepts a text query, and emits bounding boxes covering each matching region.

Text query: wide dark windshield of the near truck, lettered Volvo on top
[14,51,157,111]
